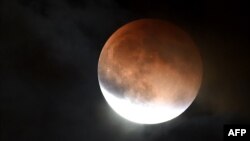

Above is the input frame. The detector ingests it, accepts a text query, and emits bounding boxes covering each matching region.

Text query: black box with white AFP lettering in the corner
[224,125,250,141]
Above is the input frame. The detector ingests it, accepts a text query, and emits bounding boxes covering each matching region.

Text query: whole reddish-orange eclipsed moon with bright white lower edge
[98,19,202,124]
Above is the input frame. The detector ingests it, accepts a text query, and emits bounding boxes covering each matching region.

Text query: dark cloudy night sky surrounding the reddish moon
[0,0,250,141]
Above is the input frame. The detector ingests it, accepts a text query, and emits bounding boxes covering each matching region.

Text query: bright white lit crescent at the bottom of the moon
[100,84,186,124]
